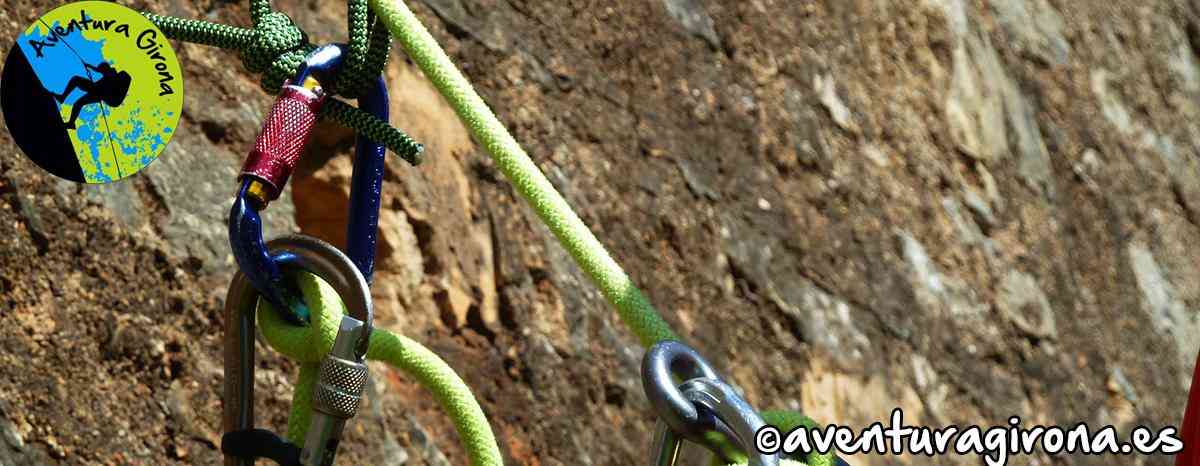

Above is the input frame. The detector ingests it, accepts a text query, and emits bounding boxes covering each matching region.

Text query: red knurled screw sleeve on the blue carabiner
[241,84,324,201]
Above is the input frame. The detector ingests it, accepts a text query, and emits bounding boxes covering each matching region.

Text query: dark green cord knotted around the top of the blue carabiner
[142,0,424,165]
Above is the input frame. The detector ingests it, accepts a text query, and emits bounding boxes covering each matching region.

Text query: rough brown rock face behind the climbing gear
[0,0,1200,465]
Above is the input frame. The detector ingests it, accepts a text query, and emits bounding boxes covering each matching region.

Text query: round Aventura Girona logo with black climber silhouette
[0,1,184,183]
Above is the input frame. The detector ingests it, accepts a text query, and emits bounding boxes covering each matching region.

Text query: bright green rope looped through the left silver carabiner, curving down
[258,273,503,466]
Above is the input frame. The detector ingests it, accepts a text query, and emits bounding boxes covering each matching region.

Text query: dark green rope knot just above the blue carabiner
[241,12,312,92]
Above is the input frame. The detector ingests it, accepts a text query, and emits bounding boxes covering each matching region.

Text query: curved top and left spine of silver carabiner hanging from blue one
[222,234,373,466]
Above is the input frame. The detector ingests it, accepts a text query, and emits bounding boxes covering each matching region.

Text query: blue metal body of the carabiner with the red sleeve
[229,44,388,324]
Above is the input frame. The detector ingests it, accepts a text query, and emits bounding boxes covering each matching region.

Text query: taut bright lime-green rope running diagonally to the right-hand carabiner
[371,0,678,346]
